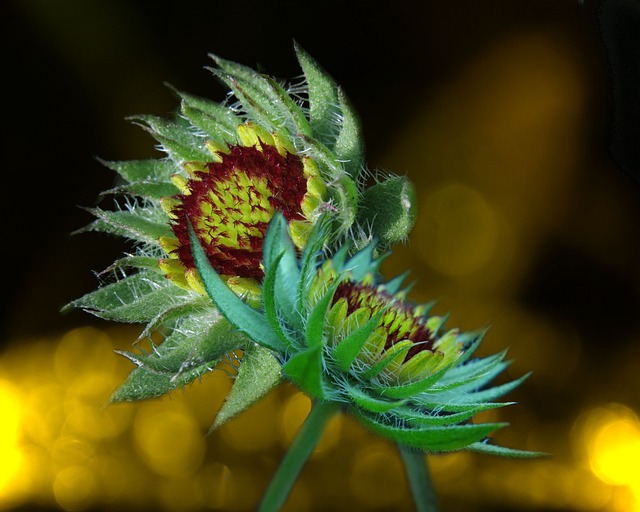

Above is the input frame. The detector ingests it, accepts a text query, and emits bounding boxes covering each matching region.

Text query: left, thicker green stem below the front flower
[259,402,339,512]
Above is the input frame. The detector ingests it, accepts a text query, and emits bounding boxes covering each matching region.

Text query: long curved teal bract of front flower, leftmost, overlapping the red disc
[189,226,286,353]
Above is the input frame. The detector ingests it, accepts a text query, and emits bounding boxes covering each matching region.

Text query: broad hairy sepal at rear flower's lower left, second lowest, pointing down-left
[109,310,248,402]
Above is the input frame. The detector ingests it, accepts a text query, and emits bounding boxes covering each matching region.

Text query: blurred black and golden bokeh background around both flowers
[0,0,640,512]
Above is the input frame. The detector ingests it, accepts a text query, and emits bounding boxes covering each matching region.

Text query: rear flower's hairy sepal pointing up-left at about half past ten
[129,115,211,162]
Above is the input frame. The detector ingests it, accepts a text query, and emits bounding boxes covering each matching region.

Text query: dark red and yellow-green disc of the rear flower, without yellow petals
[172,144,307,280]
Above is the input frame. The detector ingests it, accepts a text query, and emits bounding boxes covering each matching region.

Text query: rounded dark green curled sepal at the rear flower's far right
[358,176,417,247]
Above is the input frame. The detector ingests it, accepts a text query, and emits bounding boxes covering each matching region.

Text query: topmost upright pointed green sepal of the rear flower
[295,44,340,148]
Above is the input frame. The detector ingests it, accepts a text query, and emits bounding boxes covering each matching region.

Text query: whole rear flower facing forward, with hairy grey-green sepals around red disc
[62,46,415,418]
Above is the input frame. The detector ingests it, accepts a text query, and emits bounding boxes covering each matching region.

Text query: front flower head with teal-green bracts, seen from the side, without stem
[191,214,534,456]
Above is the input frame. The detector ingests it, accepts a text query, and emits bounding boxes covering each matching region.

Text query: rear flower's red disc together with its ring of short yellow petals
[160,123,326,292]
